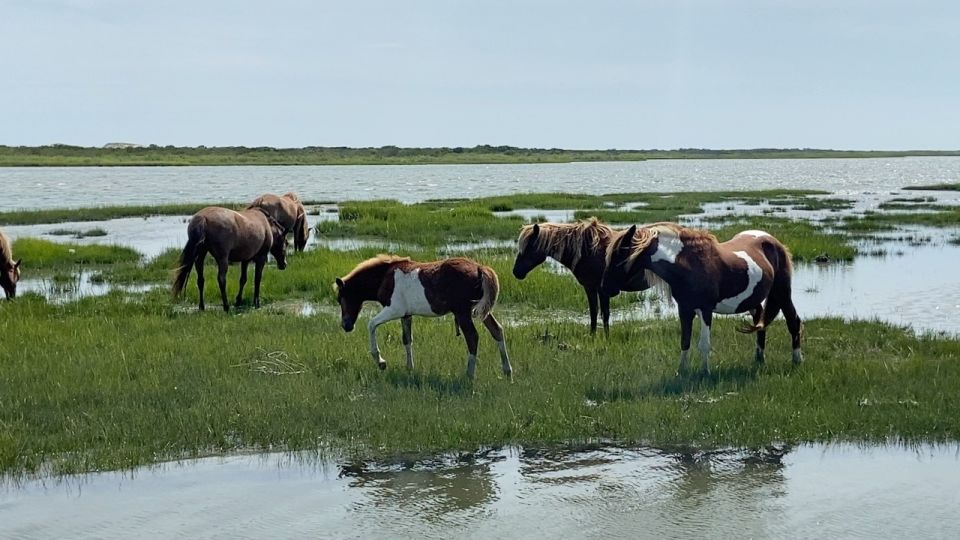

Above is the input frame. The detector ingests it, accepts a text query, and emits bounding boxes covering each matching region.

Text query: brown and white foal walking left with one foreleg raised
[336,255,513,379]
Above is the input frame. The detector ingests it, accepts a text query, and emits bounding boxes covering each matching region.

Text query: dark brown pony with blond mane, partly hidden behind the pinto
[513,218,646,334]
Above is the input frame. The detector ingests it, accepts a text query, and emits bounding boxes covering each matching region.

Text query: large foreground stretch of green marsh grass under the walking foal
[0,291,960,475]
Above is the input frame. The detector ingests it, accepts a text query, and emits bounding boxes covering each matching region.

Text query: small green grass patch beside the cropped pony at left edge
[13,238,140,268]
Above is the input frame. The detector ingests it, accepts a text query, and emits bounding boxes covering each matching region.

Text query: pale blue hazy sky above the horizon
[0,0,960,150]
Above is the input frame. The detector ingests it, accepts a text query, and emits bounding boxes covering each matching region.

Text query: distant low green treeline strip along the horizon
[0,144,960,167]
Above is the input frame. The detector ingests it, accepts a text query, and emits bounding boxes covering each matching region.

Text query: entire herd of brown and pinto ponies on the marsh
[0,193,803,378]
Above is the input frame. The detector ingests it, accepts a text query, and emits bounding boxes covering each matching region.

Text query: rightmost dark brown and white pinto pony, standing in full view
[601,223,803,373]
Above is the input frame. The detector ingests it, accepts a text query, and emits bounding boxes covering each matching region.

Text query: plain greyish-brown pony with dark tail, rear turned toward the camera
[173,206,287,311]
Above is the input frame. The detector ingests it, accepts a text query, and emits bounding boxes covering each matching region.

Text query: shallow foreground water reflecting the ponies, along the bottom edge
[0,445,960,538]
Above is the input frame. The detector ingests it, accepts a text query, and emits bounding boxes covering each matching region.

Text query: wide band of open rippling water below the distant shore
[0,157,960,211]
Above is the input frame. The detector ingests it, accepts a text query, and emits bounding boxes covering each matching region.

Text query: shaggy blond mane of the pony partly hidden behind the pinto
[517,217,614,266]
